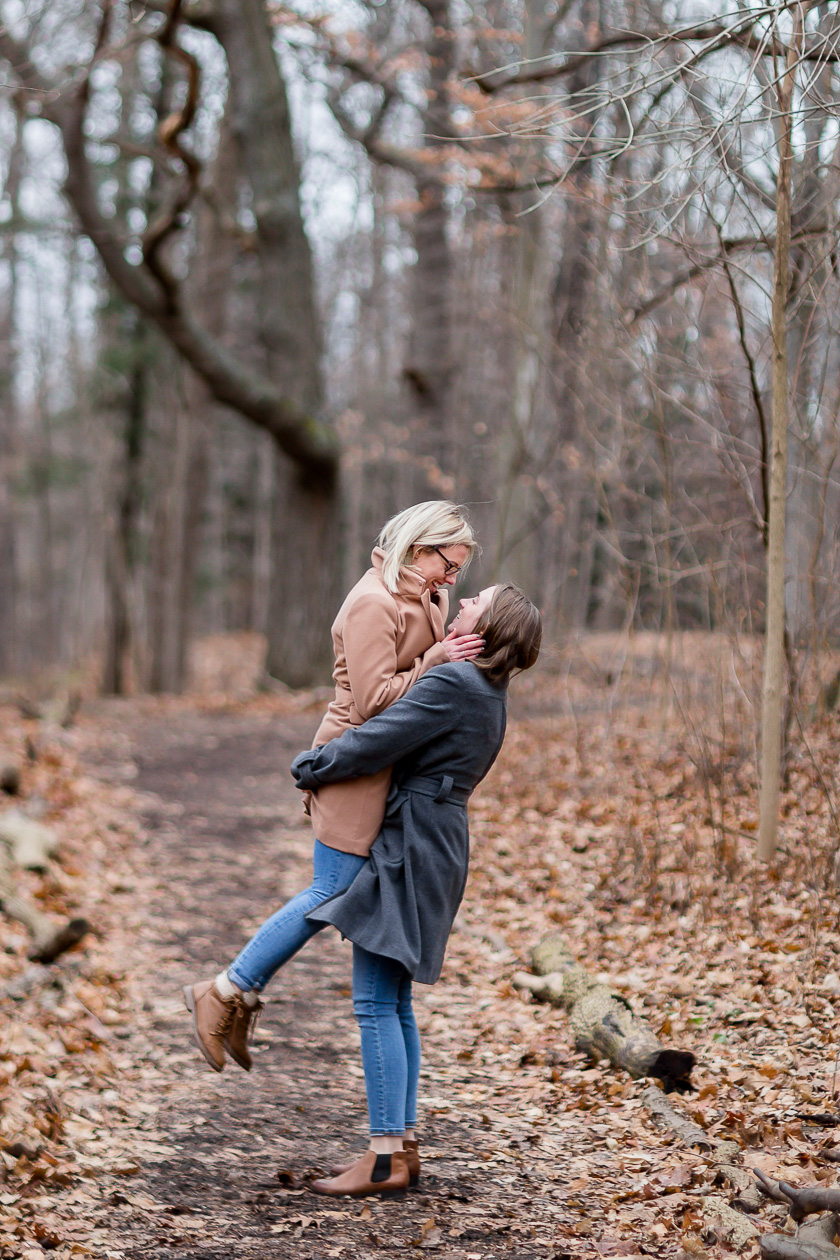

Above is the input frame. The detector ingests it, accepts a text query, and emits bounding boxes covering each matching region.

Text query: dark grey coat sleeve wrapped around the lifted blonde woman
[292,669,465,790]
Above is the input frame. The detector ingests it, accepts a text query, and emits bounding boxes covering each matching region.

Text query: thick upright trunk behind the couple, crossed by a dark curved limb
[213,0,340,687]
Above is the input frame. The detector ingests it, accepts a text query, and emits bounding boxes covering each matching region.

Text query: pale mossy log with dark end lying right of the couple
[514,935,696,1092]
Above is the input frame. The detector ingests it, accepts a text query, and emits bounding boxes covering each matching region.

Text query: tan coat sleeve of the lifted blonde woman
[343,596,448,721]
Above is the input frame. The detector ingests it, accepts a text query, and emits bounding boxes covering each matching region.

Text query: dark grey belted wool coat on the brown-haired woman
[292,662,508,984]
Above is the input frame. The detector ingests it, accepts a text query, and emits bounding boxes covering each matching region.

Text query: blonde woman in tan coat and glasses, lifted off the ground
[184,500,484,1072]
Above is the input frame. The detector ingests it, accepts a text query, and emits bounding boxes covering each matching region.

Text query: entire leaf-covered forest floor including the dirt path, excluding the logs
[0,636,840,1260]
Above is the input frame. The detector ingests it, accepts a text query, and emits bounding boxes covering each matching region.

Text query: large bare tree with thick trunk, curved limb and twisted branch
[0,0,339,684]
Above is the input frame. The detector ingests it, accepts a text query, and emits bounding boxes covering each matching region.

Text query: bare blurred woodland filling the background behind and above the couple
[0,0,840,693]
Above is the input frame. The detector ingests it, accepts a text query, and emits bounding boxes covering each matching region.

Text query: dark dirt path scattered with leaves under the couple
[81,703,579,1260]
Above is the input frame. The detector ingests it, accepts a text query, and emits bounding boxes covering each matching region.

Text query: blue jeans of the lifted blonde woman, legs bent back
[228,840,368,993]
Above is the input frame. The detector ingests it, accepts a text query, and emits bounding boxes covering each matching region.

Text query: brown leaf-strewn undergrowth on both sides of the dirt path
[0,636,840,1257]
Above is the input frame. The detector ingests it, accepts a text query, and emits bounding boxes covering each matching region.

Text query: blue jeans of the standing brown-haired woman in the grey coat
[353,945,421,1137]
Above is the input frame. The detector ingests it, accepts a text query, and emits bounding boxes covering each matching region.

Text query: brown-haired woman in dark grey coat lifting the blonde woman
[292,585,542,1196]
